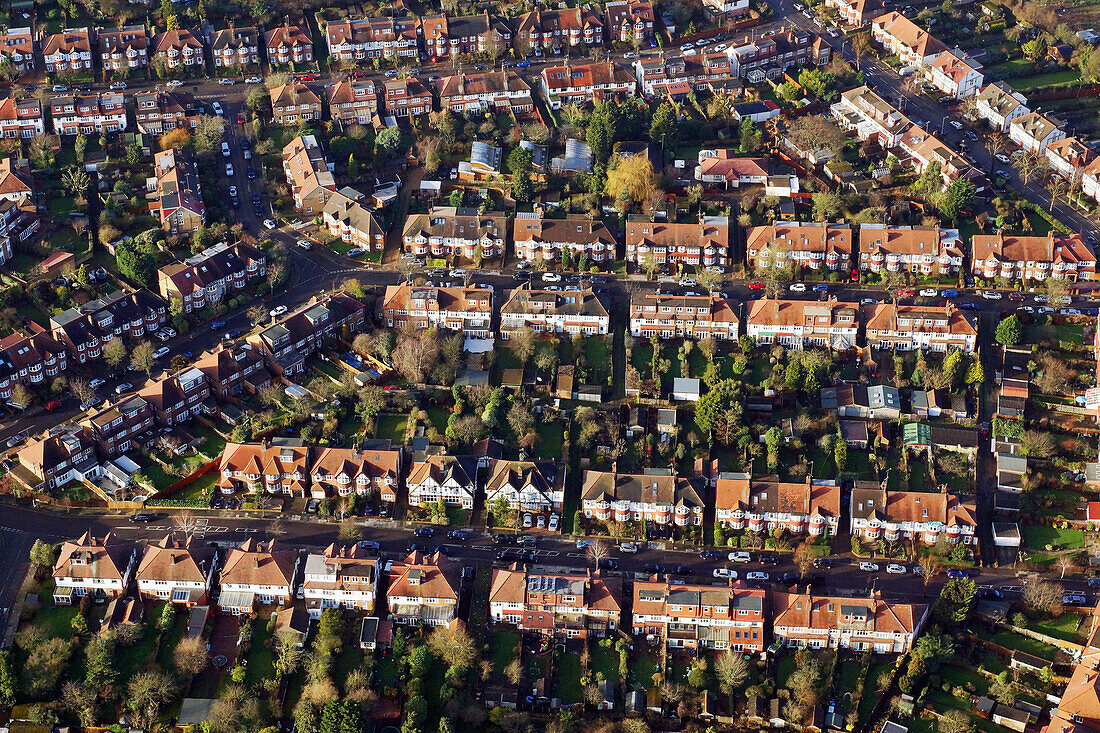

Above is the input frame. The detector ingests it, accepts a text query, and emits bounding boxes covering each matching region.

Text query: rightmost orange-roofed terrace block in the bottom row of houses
[769,592,928,654]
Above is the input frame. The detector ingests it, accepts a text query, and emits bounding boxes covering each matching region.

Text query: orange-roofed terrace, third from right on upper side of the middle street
[745,221,855,273]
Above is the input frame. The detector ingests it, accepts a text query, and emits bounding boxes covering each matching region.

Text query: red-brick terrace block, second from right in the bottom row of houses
[631,576,767,653]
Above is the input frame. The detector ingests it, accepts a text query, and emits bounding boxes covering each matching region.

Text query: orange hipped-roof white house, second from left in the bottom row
[134,535,220,608]
